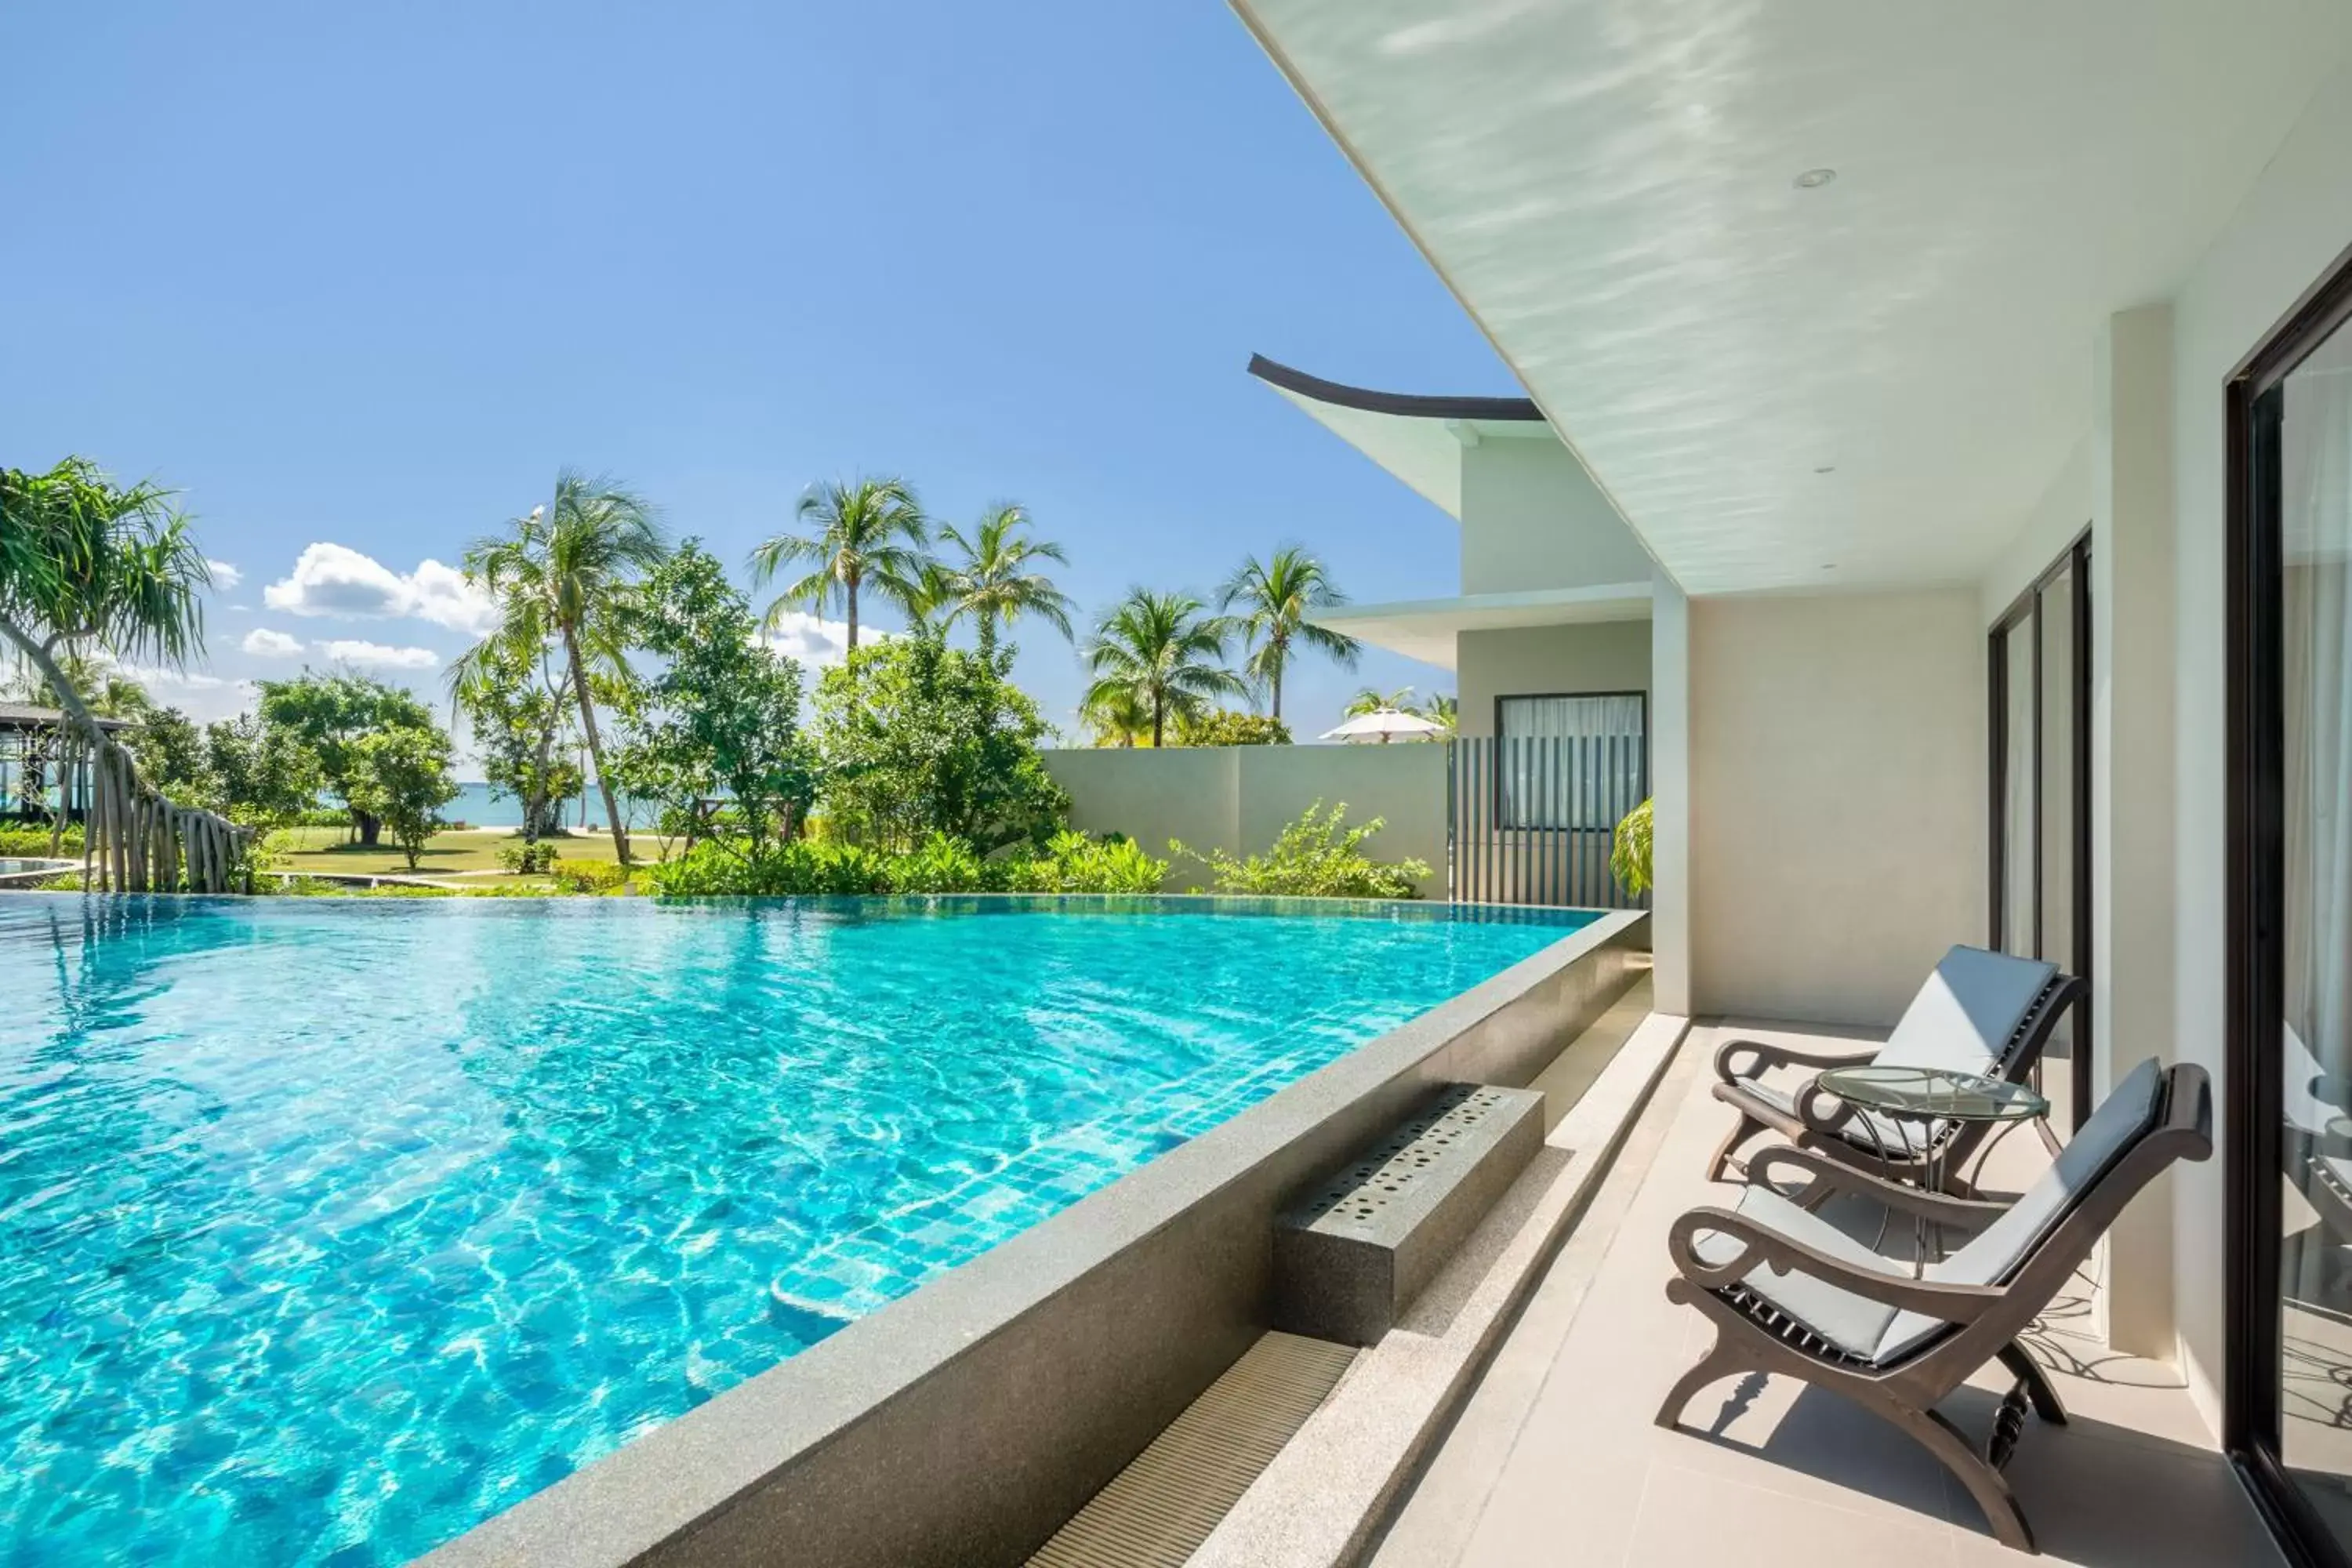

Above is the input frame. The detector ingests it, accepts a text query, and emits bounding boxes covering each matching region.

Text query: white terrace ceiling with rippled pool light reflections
[1235,0,2352,593]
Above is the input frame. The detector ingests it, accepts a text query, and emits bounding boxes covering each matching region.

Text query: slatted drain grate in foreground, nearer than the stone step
[1028,1333,1355,1568]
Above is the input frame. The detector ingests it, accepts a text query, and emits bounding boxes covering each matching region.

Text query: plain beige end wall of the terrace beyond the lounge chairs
[1661,588,1985,1025]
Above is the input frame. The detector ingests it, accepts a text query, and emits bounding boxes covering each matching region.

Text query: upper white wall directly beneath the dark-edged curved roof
[1461,433,1651,593]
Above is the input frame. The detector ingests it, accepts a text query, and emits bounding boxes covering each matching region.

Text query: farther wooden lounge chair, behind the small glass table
[1708,947,2084,1196]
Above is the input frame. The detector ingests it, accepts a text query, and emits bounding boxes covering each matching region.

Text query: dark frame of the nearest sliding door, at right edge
[2223,232,2352,1568]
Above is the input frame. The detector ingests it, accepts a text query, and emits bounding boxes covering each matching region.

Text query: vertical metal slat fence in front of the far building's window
[1446,736,1649,909]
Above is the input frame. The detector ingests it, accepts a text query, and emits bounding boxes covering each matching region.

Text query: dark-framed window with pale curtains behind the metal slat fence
[1496,691,1649,832]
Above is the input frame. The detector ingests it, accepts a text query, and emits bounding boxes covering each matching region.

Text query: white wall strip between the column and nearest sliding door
[2138,58,2352,1427]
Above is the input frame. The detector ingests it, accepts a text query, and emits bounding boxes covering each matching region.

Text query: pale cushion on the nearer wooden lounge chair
[1693,1058,2164,1366]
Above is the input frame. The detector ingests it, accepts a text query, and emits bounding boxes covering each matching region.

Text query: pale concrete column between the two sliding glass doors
[2091,306,2183,1361]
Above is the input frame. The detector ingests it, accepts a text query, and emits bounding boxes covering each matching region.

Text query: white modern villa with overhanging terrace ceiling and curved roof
[1235,0,2352,1563]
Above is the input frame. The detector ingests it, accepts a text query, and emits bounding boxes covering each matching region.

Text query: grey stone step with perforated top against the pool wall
[1275,1083,1543,1345]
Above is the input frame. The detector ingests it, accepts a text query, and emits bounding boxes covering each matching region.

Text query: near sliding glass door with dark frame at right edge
[2230,251,2352,1563]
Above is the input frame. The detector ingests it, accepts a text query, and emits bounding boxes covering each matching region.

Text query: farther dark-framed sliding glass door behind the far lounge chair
[1990,534,2091,1128]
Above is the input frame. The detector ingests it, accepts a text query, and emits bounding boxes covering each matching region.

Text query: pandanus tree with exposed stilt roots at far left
[0,459,247,891]
